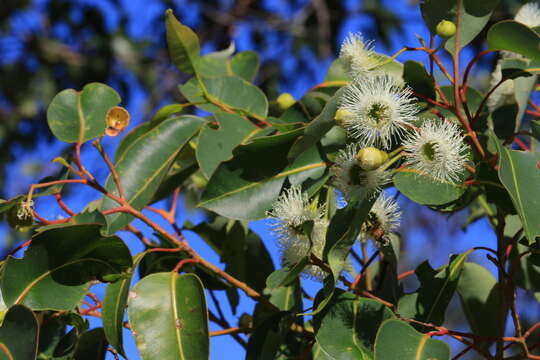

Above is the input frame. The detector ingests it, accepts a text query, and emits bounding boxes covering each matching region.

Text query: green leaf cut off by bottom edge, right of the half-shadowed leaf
[375,319,450,360]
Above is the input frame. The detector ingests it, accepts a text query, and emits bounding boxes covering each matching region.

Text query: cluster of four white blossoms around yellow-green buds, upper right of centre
[333,34,467,190]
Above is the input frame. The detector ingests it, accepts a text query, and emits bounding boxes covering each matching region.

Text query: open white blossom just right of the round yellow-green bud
[403,120,467,182]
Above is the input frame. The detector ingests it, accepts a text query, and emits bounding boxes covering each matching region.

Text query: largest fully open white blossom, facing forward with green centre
[339,75,417,149]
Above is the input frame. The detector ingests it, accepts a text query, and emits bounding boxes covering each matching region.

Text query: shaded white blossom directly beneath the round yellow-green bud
[331,143,390,201]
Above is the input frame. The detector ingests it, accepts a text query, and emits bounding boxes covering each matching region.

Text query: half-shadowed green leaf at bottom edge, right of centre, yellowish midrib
[314,290,395,360]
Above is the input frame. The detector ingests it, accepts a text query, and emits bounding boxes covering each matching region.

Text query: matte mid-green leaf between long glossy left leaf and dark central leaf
[197,113,258,178]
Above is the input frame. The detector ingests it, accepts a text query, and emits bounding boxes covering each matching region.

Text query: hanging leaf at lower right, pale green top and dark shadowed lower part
[457,262,505,337]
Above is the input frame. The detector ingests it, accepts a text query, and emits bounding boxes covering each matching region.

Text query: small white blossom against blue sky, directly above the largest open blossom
[339,33,380,78]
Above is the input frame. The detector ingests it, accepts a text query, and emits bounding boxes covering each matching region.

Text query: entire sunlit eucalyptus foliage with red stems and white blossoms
[0,0,540,360]
